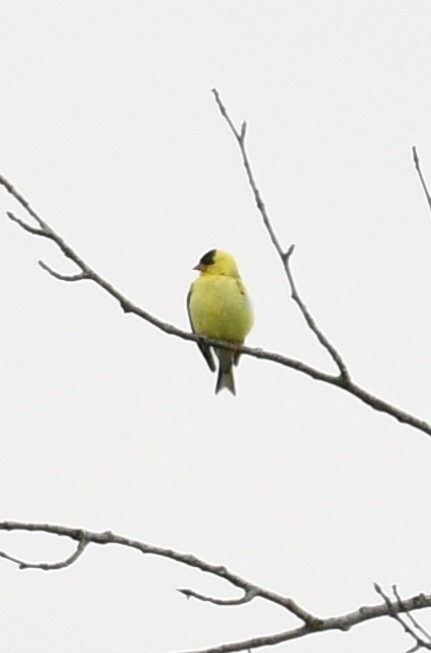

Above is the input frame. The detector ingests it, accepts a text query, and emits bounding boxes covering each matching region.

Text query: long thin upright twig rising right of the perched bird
[212,88,349,381]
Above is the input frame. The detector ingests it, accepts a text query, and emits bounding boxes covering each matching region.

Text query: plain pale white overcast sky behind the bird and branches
[0,0,431,653]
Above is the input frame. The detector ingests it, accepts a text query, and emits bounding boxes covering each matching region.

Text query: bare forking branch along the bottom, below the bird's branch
[0,521,431,653]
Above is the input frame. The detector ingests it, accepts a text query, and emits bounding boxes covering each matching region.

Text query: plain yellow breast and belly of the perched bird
[189,275,253,342]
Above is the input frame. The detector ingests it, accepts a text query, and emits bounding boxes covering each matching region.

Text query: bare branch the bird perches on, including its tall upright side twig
[0,105,431,435]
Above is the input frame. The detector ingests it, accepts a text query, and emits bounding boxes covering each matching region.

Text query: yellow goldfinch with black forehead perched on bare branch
[187,249,253,394]
